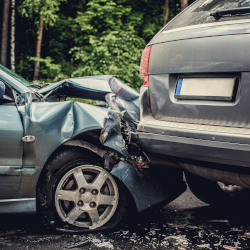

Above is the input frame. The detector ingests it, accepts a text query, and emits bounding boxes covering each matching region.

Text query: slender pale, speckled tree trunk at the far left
[10,0,15,72]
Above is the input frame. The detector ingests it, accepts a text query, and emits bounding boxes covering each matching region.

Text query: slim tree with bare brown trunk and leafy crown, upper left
[20,0,66,80]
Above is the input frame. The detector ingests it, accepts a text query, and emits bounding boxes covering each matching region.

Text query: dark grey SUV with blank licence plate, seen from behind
[134,0,250,204]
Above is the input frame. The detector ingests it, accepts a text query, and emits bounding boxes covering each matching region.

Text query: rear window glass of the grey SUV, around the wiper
[164,0,250,31]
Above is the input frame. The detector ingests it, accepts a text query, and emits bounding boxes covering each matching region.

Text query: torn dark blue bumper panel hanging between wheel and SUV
[111,161,186,212]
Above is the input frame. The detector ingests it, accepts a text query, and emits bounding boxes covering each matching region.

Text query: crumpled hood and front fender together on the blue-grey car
[18,76,140,165]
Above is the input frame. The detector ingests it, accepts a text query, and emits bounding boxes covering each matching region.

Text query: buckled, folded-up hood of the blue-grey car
[37,75,140,124]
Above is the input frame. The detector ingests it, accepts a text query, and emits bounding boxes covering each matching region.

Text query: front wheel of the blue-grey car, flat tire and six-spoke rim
[37,147,130,233]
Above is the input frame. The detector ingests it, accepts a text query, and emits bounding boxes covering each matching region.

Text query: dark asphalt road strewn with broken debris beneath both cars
[0,190,250,250]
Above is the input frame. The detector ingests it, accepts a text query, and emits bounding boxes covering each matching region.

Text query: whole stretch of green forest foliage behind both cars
[13,0,193,89]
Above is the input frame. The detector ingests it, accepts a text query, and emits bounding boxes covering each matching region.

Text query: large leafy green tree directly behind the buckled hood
[71,0,146,88]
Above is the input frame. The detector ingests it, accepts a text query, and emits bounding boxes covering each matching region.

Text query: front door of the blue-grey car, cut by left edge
[0,79,23,199]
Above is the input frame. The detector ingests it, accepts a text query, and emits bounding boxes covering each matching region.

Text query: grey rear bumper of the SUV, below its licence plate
[137,87,250,167]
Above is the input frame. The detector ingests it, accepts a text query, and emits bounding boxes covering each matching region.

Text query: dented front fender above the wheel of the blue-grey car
[18,93,126,167]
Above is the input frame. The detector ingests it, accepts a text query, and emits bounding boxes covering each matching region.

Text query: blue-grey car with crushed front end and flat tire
[0,65,186,232]
